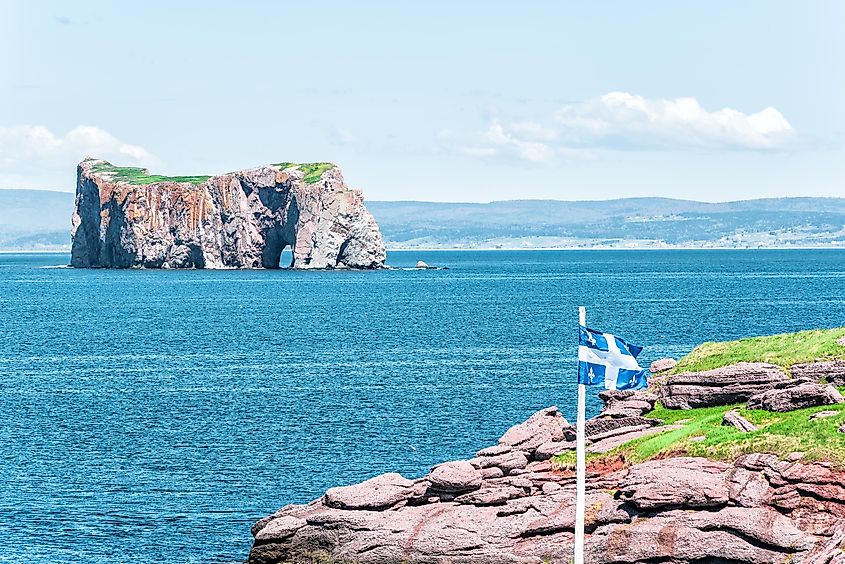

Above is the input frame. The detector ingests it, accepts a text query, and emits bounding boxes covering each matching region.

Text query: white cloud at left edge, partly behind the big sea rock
[0,125,158,188]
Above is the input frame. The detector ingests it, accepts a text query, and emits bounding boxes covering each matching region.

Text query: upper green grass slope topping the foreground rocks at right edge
[672,327,845,374]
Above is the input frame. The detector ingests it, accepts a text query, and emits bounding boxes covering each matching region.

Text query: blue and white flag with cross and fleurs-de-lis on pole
[578,325,648,390]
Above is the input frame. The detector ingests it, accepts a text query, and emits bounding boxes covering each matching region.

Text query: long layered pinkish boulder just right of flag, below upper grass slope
[660,362,789,409]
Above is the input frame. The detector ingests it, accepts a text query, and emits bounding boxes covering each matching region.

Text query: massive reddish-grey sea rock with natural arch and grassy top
[71,160,385,269]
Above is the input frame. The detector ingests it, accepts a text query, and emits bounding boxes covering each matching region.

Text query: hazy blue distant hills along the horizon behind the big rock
[0,190,845,250]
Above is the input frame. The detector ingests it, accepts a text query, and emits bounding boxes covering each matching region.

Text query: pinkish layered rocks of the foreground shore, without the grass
[249,361,845,564]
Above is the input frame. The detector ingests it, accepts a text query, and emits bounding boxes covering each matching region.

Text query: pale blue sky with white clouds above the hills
[0,0,845,202]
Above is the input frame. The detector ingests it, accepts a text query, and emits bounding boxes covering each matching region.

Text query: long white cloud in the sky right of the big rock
[439,92,795,163]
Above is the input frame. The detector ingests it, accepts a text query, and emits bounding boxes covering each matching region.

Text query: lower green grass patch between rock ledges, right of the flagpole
[553,403,845,468]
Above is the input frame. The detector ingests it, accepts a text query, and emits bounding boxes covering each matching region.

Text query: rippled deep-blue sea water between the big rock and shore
[0,250,845,562]
